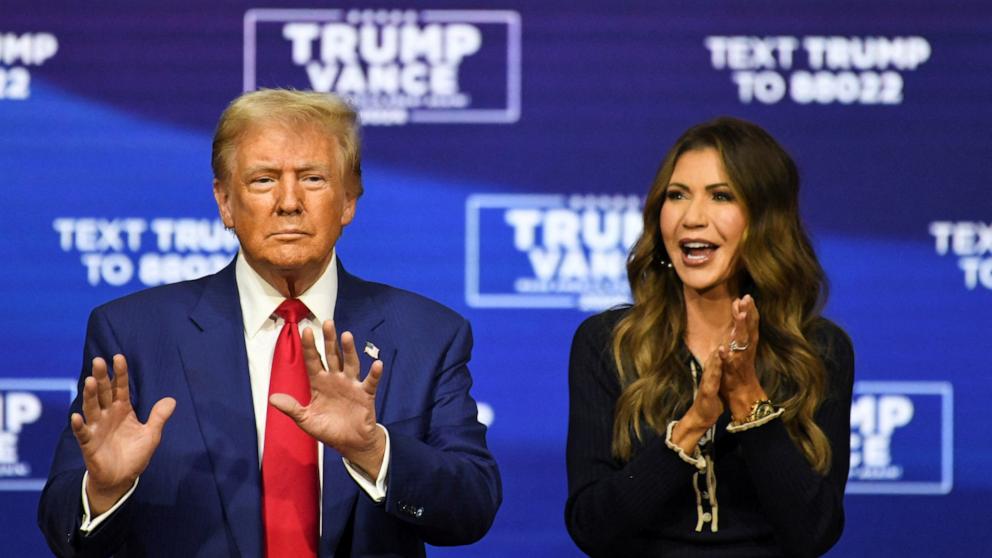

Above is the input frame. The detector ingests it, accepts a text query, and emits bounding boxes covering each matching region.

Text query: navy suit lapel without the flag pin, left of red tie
[179,262,262,556]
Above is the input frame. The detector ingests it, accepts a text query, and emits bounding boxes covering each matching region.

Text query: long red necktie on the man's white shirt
[262,298,320,558]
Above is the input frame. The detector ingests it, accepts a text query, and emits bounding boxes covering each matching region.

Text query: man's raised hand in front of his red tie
[269,320,386,479]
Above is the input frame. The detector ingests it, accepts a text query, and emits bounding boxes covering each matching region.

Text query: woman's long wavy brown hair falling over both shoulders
[613,117,830,474]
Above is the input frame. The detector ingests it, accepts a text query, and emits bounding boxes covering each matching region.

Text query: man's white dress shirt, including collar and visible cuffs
[80,252,389,533]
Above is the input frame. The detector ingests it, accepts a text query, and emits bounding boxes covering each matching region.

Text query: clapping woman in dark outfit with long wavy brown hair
[565,118,854,557]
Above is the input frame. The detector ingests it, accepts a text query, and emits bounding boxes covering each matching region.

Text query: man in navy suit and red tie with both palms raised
[38,90,501,558]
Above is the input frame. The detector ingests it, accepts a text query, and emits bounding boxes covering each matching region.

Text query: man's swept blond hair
[210,89,364,197]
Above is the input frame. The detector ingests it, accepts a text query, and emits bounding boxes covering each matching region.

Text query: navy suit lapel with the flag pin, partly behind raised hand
[321,260,396,551]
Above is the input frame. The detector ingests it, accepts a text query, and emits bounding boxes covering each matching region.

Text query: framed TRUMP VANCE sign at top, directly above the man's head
[244,8,521,125]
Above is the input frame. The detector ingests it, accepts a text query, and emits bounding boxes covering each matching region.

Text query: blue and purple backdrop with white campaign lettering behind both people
[0,0,992,556]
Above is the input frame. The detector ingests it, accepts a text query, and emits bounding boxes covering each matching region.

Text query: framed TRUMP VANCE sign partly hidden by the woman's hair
[465,194,642,310]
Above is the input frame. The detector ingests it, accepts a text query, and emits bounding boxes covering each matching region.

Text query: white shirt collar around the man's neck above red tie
[234,251,338,338]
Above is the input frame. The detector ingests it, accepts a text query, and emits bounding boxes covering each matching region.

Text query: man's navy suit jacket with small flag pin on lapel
[38,262,502,558]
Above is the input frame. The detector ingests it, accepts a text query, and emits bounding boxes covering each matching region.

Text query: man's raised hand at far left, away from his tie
[70,354,176,517]
